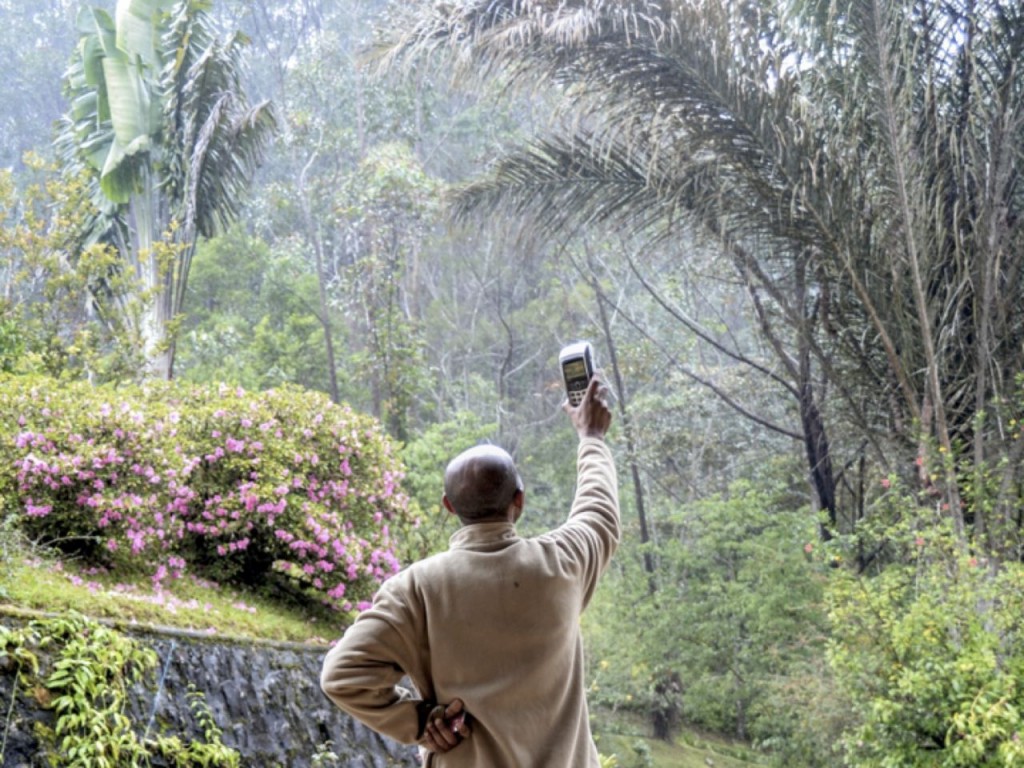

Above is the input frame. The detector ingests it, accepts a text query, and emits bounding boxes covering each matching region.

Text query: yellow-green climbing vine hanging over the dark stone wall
[0,612,240,768]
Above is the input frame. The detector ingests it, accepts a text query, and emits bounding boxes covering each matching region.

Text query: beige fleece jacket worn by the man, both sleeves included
[321,438,620,768]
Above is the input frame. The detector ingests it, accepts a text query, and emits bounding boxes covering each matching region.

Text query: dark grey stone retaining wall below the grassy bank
[0,617,419,768]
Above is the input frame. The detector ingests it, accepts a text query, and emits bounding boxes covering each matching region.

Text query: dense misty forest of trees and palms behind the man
[0,0,1024,766]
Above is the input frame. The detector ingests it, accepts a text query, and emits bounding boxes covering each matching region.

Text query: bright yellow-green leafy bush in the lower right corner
[828,512,1024,768]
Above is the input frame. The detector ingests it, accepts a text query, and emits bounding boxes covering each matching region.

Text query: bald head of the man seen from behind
[444,445,522,522]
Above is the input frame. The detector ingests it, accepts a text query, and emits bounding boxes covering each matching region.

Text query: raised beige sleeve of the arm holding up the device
[554,437,622,606]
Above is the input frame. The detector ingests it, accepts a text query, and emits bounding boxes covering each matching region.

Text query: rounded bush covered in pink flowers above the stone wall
[0,378,410,610]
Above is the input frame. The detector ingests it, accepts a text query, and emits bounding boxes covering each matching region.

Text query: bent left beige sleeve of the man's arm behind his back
[321,577,432,744]
